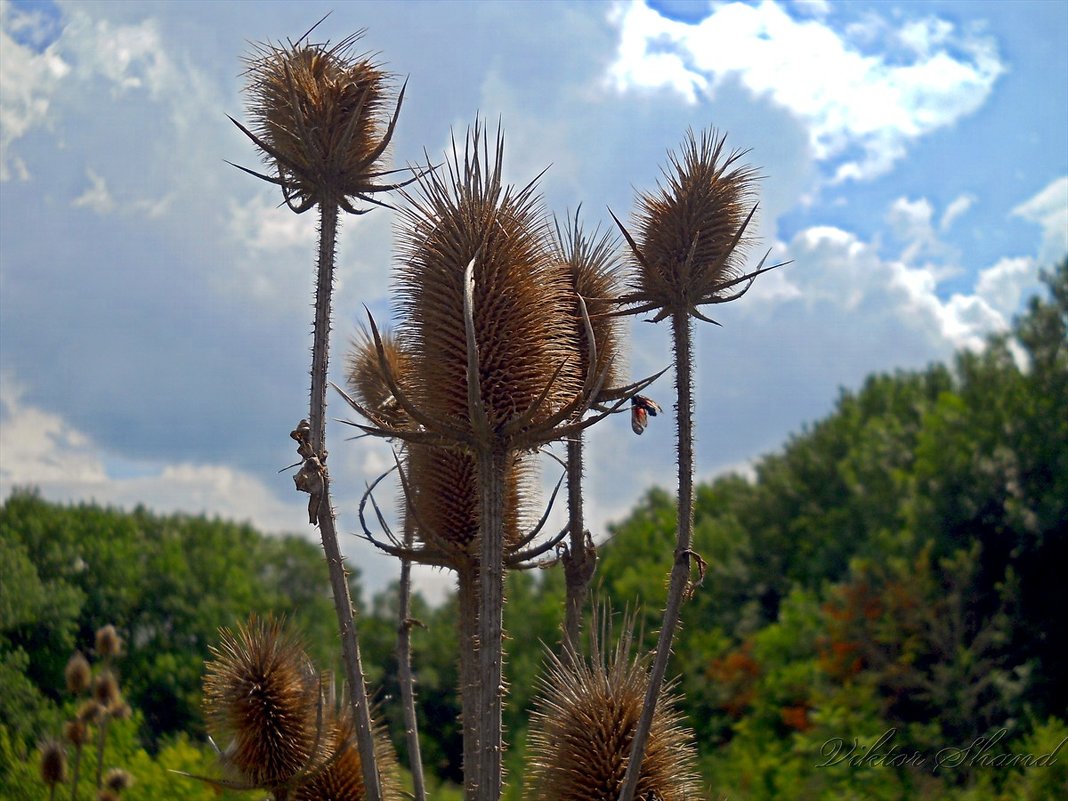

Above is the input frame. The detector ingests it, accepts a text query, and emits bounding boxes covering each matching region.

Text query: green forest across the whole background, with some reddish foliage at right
[0,261,1068,801]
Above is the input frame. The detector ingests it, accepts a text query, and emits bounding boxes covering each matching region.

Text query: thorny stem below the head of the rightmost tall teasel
[619,309,693,801]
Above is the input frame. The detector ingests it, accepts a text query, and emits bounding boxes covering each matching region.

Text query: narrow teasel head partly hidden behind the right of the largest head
[553,211,622,397]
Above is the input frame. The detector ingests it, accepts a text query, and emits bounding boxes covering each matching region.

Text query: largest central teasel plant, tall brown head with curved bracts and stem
[337,122,662,801]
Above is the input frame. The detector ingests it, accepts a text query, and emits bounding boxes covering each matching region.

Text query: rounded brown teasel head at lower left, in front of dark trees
[204,615,318,788]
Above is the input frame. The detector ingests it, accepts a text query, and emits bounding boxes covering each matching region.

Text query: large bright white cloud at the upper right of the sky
[609,0,1004,183]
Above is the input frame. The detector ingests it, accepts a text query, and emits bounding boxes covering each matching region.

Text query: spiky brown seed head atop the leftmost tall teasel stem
[234,31,404,214]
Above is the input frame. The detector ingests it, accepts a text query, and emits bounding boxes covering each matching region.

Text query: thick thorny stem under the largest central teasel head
[476,442,508,801]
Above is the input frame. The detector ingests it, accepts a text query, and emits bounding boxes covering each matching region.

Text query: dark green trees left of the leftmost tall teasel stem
[0,490,356,748]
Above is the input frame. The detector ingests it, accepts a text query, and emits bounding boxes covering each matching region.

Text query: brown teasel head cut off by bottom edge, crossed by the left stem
[292,716,407,801]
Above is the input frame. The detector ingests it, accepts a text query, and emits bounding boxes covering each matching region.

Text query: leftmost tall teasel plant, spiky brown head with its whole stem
[231,20,420,801]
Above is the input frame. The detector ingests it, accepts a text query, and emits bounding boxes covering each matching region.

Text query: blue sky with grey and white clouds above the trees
[0,0,1068,602]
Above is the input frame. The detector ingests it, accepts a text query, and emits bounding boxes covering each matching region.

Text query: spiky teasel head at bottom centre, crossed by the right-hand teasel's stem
[524,624,701,801]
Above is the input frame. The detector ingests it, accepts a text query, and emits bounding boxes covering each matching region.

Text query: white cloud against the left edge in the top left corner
[0,0,70,182]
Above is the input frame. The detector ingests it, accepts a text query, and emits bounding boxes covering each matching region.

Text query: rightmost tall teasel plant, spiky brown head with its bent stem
[612,129,783,801]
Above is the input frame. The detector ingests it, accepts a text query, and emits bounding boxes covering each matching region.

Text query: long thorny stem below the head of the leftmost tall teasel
[309,203,382,801]
